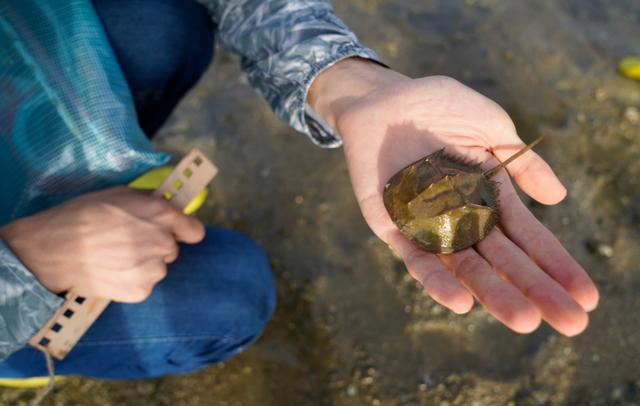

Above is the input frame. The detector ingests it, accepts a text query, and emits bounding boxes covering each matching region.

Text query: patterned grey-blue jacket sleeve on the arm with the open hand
[199,0,379,148]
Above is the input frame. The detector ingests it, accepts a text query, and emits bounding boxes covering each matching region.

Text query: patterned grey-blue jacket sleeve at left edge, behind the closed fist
[0,240,63,361]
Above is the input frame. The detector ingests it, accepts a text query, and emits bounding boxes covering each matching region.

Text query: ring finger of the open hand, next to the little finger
[439,249,541,333]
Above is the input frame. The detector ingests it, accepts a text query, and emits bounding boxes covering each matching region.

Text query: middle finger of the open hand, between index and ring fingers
[476,229,589,336]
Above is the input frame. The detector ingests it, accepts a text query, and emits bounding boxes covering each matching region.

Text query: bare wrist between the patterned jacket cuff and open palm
[307,57,409,135]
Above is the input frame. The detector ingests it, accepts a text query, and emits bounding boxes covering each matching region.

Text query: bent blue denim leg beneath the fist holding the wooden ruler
[0,228,275,379]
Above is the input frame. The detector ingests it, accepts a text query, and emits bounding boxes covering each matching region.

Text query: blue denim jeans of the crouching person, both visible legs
[0,0,275,379]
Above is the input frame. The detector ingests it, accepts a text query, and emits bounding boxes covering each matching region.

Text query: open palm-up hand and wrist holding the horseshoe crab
[308,59,598,336]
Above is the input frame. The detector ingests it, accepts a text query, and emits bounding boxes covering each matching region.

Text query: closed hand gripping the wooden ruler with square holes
[0,186,204,303]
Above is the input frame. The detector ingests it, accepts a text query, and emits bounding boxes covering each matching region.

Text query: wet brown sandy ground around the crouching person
[0,0,640,406]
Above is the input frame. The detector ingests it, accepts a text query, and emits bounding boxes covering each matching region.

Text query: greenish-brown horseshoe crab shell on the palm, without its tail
[384,150,499,254]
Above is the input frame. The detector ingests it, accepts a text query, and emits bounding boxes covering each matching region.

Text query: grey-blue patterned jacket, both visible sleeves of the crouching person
[0,0,377,360]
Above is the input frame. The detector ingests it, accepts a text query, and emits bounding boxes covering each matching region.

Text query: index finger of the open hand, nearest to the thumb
[498,175,599,311]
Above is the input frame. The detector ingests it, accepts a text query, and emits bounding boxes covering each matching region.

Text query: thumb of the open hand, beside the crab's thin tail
[493,141,567,204]
